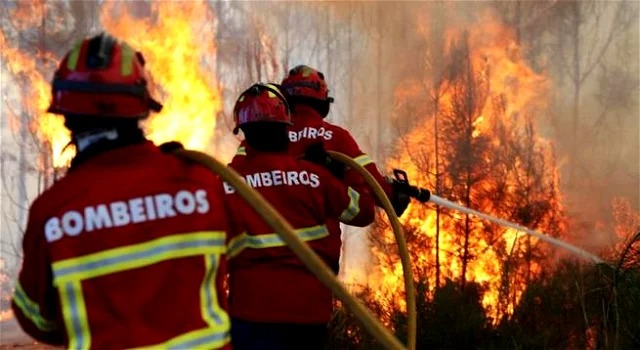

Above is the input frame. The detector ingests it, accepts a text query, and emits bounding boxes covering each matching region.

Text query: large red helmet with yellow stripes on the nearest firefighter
[49,33,162,118]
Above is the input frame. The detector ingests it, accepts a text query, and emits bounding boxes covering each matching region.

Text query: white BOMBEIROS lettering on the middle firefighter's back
[223,170,320,194]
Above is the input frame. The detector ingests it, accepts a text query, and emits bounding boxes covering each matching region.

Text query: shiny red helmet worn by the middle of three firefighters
[233,83,293,134]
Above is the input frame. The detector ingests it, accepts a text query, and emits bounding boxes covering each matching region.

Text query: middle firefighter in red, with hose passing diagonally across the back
[224,84,374,350]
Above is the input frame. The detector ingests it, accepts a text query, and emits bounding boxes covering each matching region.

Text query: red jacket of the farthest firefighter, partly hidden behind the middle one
[234,105,393,205]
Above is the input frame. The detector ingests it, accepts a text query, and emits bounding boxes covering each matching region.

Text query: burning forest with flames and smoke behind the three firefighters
[0,0,640,349]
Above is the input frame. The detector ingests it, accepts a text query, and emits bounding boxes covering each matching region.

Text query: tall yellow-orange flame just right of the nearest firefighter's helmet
[101,1,222,150]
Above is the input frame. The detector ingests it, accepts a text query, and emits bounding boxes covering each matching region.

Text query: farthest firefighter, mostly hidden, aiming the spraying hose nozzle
[237,65,410,216]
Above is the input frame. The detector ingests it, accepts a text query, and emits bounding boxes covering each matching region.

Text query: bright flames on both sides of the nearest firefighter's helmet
[0,1,222,172]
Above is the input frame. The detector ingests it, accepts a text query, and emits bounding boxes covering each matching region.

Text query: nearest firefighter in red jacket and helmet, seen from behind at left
[12,34,230,349]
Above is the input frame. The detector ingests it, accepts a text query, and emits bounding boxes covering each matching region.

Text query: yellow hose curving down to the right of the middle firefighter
[328,151,417,350]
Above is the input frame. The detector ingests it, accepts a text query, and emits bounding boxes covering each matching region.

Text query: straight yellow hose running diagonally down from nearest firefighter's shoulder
[174,149,405,349]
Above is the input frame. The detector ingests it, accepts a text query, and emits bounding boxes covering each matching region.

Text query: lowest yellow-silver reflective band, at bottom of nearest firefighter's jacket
[132,326,231,350]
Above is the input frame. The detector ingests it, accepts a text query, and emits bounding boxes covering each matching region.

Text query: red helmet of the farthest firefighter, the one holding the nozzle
[282,65,333,102]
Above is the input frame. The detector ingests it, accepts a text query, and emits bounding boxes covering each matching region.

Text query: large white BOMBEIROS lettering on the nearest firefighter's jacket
[44,189,210,242]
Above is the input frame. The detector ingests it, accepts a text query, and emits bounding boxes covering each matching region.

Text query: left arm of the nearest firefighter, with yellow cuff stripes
[11,202,64,345]
